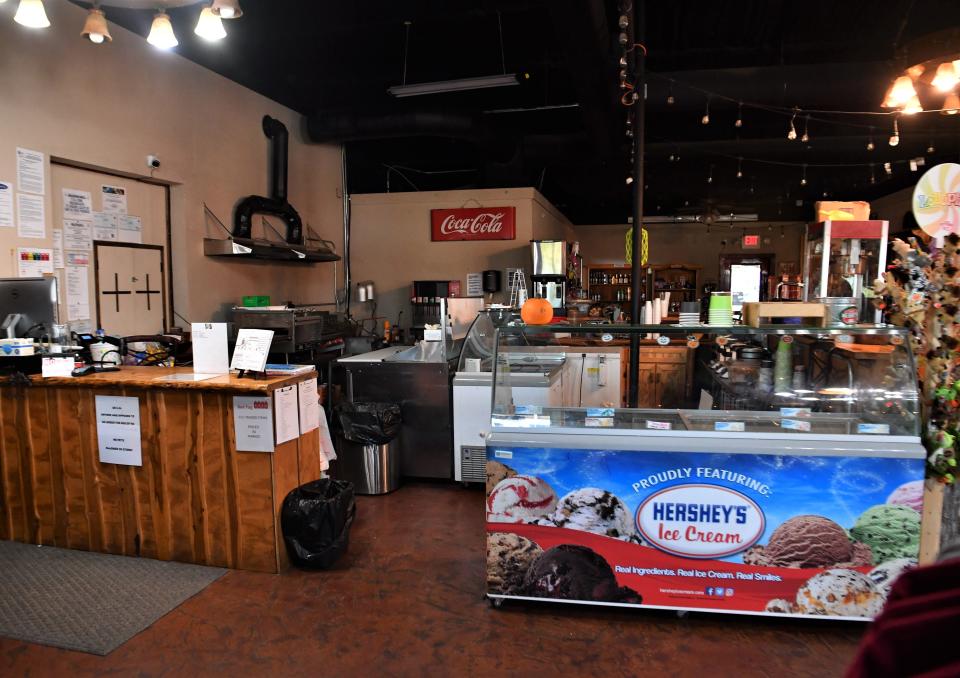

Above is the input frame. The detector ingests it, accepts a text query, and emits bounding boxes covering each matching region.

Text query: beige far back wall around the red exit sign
[574,222,804,285]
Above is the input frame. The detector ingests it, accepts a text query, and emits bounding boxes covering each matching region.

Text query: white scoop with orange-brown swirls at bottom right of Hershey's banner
[797,569,883,617]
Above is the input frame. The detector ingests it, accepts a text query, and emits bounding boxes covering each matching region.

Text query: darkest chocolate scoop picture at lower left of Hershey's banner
[523,544,642,603]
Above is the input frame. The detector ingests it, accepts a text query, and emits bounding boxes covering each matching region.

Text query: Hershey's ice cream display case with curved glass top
[486,325,925,620]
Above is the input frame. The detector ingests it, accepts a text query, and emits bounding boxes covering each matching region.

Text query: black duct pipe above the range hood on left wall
[233,115,303,245]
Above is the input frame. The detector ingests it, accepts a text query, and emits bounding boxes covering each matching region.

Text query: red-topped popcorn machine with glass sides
[803,220,889,322]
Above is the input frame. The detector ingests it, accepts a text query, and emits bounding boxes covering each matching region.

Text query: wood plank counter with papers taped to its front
[0,367,320,572]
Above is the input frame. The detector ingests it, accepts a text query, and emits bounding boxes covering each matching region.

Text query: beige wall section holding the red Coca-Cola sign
[350,188,573,327]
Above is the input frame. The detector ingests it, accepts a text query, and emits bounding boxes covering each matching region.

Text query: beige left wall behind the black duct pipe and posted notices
[0,2,342,323]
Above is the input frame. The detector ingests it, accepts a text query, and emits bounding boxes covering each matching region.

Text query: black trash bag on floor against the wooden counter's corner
[280,478,357,568]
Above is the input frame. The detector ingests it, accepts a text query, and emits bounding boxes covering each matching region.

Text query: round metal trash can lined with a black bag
[337,402,402,494]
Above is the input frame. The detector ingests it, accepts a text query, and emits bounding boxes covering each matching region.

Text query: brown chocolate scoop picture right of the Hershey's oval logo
[743,515,872,568]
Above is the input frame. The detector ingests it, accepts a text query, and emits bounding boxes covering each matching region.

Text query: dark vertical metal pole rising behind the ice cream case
[627,0,647,407]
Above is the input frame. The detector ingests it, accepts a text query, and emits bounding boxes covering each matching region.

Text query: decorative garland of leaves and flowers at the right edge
[874,234,960,484]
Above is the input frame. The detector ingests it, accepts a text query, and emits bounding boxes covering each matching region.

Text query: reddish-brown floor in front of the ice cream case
[0,484,864,678]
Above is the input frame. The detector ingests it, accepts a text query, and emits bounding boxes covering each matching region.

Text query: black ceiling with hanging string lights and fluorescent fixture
[71,0,960,223]
